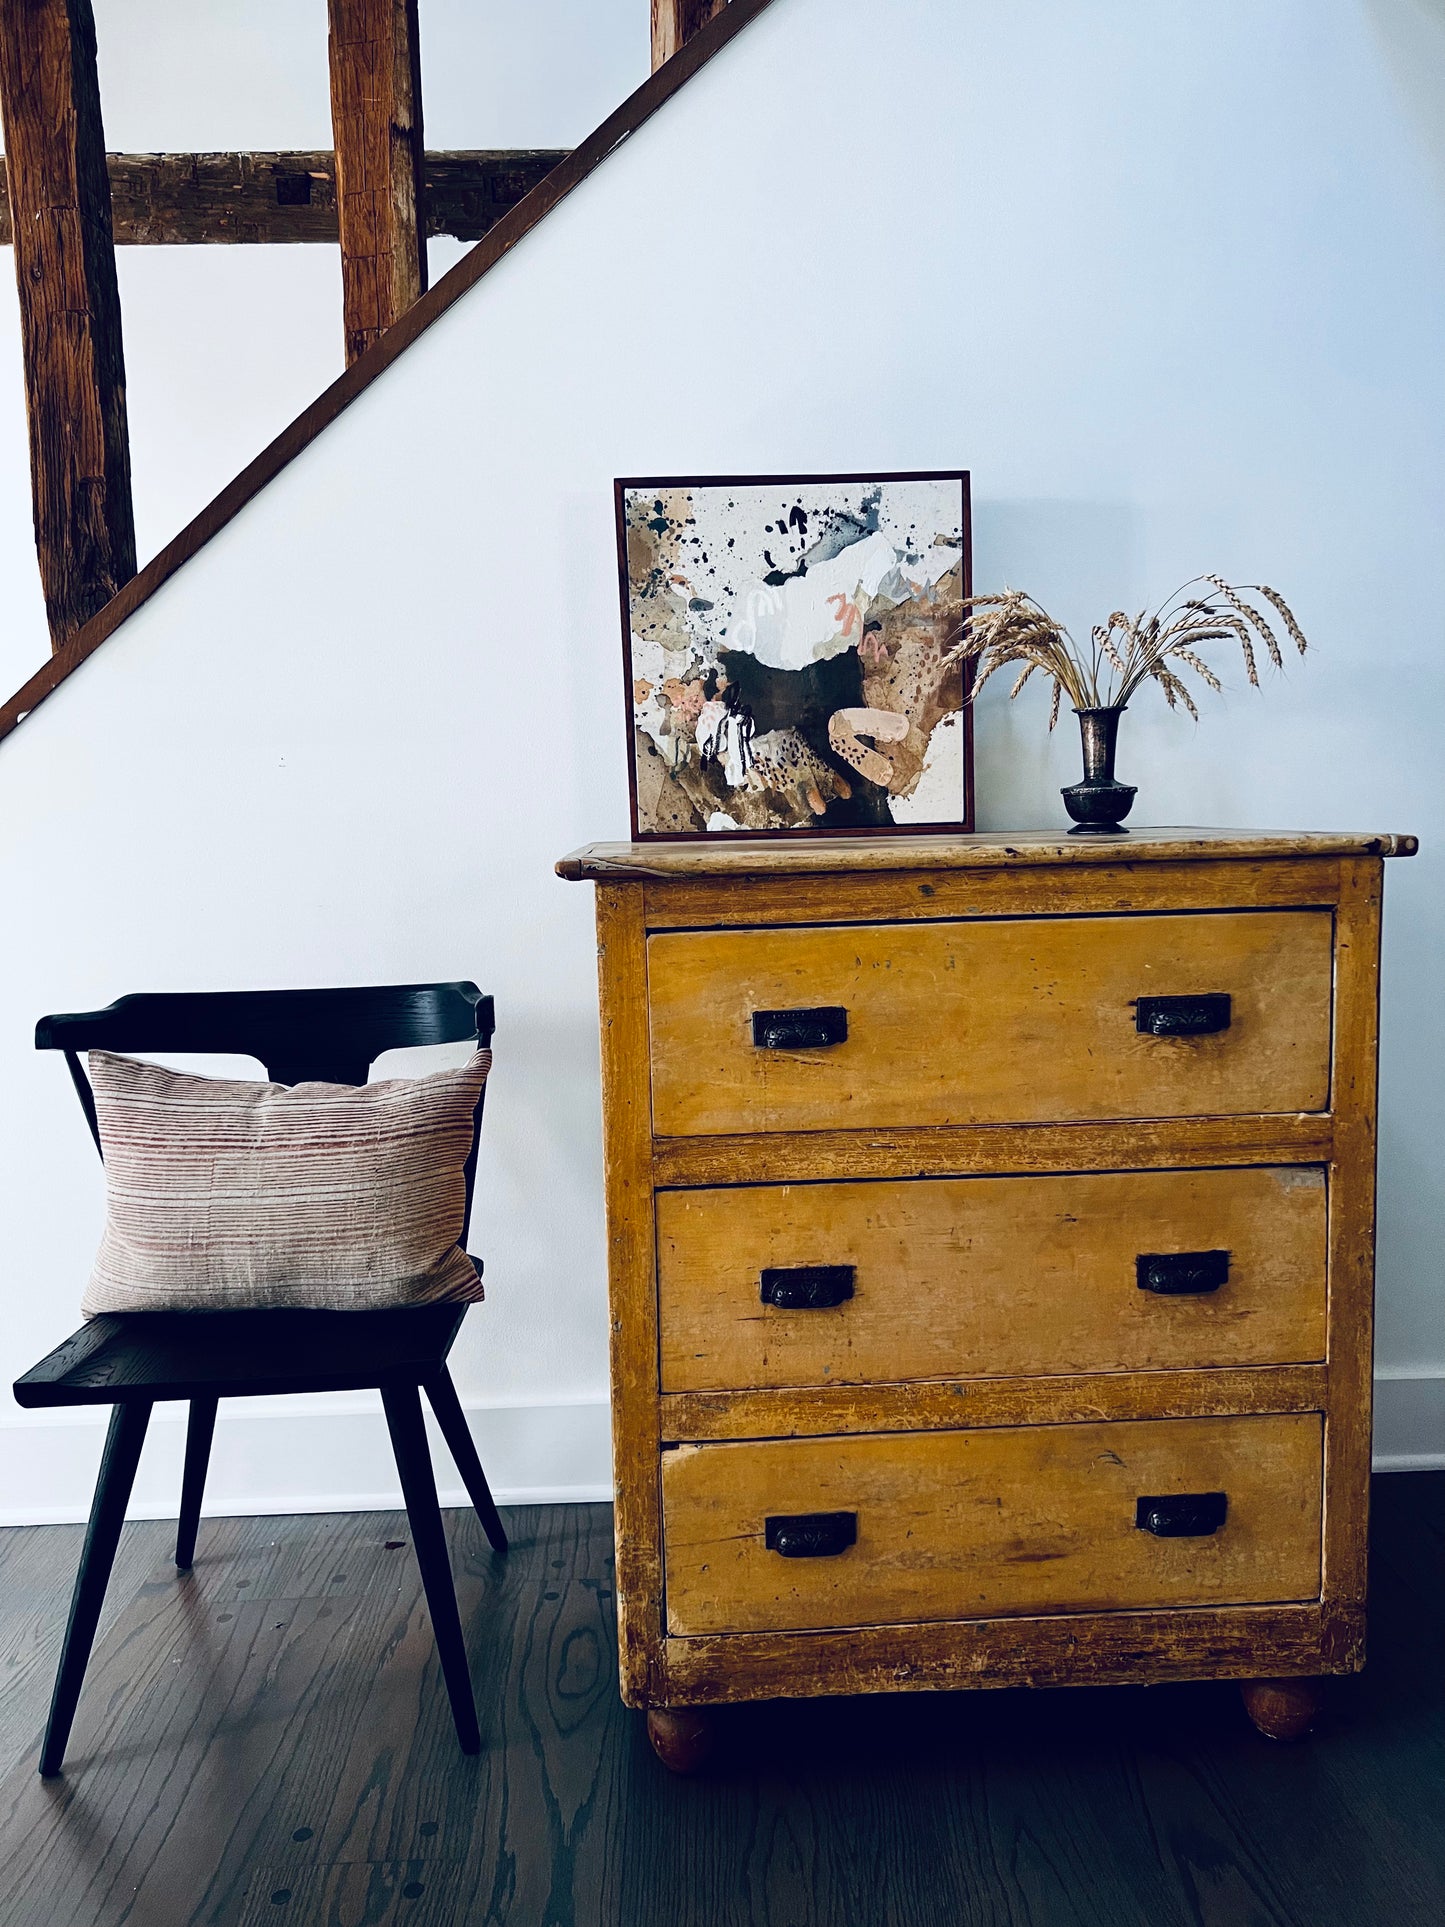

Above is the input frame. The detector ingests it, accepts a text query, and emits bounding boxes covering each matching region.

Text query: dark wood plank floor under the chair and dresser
[0,1474,1445,1927]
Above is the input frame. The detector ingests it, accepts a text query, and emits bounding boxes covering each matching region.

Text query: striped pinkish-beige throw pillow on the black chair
[81,1050,491,1318]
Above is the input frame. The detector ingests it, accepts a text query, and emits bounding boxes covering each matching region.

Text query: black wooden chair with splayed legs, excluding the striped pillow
[15,983,507,1775]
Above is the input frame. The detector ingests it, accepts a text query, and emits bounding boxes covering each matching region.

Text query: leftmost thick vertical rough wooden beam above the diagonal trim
[0,0,135,649]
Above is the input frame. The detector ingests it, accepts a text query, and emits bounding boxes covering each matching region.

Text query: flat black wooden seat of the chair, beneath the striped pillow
[15,1305,466,1407]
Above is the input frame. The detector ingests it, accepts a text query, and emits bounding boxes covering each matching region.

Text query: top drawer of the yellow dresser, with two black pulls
[647,910,1333,1137]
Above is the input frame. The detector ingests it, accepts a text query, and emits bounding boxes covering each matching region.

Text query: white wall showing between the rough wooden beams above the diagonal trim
[0,0,649,696]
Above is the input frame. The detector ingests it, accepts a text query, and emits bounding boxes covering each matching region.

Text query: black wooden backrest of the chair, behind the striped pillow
[35,983,493,1222]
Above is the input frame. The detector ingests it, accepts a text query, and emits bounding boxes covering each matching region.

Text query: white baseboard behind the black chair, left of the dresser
[0,1393,613,1526]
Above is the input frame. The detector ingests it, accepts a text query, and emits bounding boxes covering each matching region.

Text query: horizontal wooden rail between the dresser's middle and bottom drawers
[661,1364,1329,1443]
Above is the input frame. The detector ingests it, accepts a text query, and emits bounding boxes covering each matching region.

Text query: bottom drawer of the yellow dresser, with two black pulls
[663,1412,1324,1636]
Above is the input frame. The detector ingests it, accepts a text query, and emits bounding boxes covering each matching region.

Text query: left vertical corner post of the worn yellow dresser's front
[597,888,663,1705]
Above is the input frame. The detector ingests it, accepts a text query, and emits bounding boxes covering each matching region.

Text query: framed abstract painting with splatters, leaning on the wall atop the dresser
[617,470,973,838]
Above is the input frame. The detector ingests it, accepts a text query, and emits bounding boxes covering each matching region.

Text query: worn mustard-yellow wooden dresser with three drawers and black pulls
[557,829,1414,1767]
